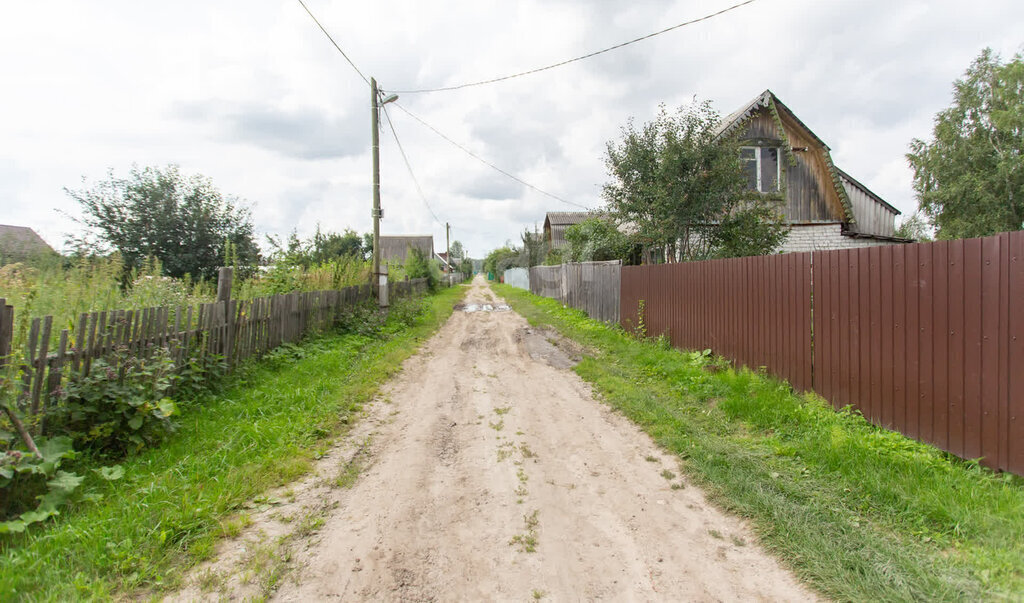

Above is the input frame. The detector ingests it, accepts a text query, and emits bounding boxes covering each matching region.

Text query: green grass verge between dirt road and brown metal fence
[495,286,1024,600]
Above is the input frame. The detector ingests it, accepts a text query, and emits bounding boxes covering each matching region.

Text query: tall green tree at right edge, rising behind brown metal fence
[906,48,1024,239]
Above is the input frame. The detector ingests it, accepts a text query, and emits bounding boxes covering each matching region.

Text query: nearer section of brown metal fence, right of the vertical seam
[813,232,1024,474]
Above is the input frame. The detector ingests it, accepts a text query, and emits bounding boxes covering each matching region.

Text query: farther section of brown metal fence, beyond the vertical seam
[621,253,811,389]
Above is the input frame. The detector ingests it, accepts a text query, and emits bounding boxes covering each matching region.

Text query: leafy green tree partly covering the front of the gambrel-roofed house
[603,101,786,262]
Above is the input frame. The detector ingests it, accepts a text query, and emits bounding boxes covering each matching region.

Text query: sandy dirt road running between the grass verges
[174,279,813,601]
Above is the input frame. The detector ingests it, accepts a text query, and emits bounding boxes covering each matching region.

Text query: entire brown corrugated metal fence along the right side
[621,232,1024,475]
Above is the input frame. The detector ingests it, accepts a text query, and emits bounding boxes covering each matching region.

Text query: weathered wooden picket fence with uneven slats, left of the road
[0,274,427,430]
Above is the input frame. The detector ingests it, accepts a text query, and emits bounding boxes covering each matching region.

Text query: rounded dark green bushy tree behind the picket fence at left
[65,165,259,277]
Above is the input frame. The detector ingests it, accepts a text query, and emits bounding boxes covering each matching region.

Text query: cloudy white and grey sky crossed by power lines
[0,0,1024,257]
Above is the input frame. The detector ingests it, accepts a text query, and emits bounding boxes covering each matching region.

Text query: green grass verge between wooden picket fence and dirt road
[0,288,465,601]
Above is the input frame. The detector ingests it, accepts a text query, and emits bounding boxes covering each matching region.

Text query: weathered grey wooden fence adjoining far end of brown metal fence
[529,261,623,321]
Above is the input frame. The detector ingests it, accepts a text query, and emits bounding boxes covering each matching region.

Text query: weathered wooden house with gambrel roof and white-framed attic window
[716,90,908,253]
